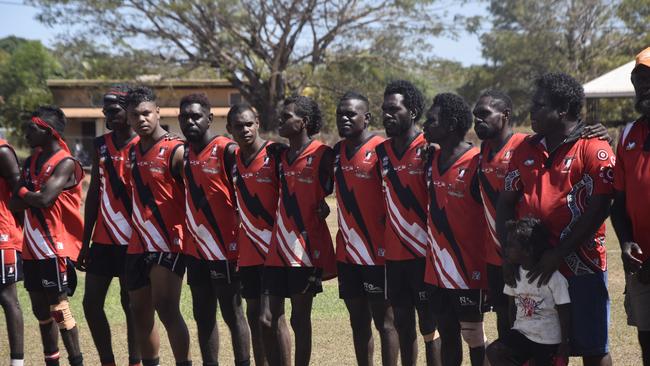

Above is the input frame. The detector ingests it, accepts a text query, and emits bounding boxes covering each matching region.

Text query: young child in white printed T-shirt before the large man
[487,218,571,366]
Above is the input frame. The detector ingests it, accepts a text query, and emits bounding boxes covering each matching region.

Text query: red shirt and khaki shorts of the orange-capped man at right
[614,118,650,331]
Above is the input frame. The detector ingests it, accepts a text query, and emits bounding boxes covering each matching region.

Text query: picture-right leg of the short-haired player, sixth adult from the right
[370,299,399,366]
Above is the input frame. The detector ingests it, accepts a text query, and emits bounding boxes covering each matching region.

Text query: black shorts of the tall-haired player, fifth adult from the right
[386,258,430,309]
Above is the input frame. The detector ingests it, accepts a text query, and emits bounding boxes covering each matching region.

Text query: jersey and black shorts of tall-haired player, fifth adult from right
[375,133,428,307]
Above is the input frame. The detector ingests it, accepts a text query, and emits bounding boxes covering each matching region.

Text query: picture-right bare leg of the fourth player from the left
[149,264,190,365]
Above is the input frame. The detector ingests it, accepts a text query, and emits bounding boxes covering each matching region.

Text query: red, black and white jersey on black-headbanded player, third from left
[93,133,140,245]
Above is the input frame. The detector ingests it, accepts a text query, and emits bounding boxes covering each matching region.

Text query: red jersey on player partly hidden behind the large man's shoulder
[478,133,527,266]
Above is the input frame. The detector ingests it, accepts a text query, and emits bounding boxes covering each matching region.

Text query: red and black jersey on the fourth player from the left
[127,134,185,253]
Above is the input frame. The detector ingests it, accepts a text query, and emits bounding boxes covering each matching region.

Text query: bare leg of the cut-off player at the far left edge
[0,280,24,361]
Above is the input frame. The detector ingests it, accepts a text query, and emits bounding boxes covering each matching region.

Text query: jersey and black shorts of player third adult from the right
[478,133,527,306]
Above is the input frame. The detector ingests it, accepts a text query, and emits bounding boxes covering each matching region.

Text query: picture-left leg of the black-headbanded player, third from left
[83,273,115,365]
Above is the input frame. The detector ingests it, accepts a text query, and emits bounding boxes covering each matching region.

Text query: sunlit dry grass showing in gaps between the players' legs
[0,209,641,365]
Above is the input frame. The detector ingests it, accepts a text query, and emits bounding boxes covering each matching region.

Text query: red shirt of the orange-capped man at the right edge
[614,119,650,261]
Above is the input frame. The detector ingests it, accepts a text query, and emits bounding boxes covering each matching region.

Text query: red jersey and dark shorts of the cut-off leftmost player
[0,139,23,288]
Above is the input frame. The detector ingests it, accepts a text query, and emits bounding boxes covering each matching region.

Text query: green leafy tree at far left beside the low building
[0,37,61,132]
